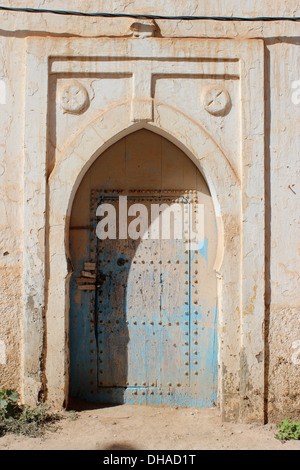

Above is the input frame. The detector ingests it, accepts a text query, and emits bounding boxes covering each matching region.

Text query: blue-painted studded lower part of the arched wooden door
[71,191,217,406]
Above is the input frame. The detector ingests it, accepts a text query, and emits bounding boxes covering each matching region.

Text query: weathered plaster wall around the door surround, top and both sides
[0,0,300,421]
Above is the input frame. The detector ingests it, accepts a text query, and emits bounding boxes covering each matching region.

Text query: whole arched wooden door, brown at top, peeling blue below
[69,129,217,406]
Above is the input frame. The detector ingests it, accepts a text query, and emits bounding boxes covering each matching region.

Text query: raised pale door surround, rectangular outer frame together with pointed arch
[22,38,265,422]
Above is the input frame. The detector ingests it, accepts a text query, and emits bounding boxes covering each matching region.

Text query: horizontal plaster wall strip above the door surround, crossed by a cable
[1,0,300,38]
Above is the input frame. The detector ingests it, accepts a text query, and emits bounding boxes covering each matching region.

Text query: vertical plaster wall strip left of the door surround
[0,37,25,389]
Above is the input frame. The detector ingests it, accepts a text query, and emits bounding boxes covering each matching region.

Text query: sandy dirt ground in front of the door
[0,405,300,450]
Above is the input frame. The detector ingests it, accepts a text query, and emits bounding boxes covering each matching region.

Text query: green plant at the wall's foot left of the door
[0,389,62,437]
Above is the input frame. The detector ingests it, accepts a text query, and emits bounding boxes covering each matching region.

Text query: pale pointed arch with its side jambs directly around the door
[46,101,241,418]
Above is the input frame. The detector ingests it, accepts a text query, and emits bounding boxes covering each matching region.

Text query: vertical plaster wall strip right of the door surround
[268,41,300,420]
